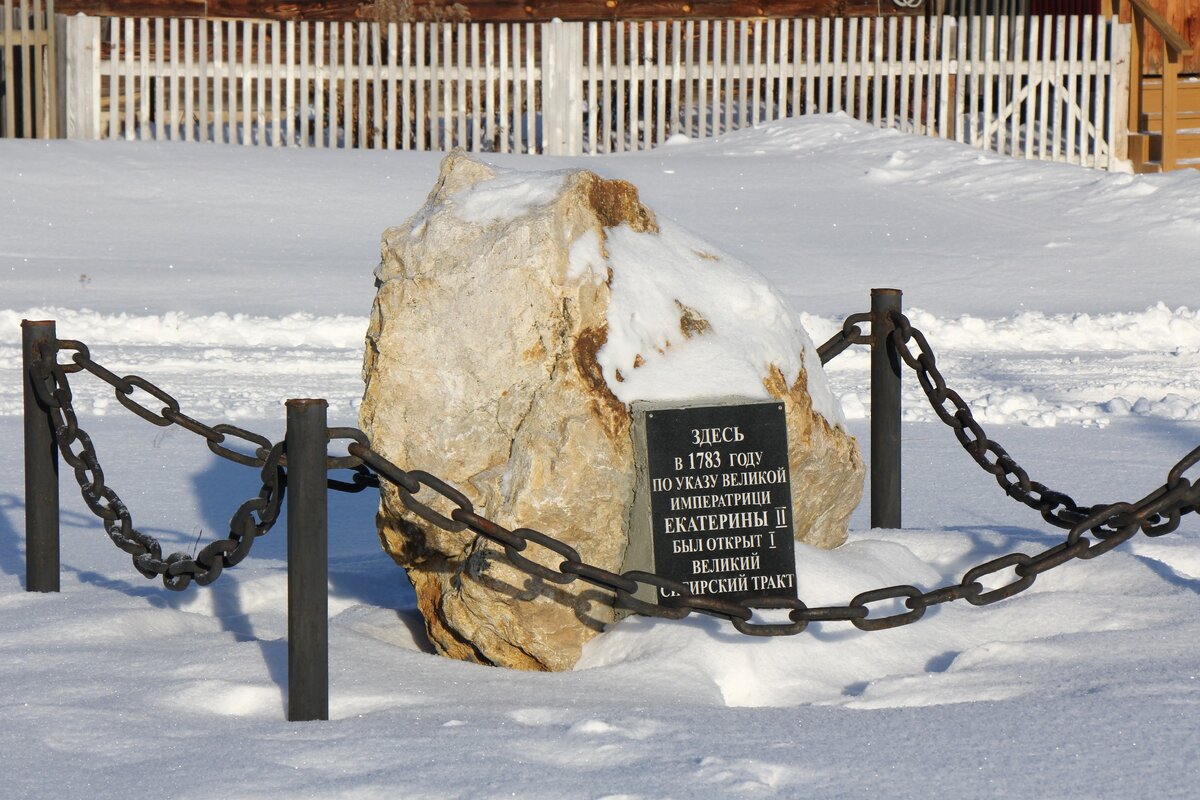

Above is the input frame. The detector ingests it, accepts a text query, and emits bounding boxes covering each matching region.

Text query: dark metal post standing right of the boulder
[871,289,901,528]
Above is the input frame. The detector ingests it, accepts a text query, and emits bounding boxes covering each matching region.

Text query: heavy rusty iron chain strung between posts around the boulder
[34,328,1200,636]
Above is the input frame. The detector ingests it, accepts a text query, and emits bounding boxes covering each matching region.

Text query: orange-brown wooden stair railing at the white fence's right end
[1111,0,1192,172]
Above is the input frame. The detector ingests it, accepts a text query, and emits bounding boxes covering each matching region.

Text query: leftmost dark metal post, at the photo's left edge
[20,319,59,591]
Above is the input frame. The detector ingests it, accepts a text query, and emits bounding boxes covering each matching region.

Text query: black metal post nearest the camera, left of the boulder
[287,399,329,722]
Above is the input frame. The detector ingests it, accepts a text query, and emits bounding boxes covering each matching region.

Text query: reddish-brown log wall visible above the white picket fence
[51,0,924,22]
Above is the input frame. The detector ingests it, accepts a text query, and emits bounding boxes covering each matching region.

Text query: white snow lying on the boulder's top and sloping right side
[441,158,845,425]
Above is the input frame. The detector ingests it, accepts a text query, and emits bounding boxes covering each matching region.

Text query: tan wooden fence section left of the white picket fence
[0,0,59,139]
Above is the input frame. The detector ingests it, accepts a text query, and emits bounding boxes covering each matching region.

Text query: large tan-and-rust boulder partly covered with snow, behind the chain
[360,152,863,669]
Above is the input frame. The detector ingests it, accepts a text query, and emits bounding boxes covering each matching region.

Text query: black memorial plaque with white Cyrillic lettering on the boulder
[646,403,796,601]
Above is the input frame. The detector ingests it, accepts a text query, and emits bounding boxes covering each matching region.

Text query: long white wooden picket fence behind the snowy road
[62,17,1129,167]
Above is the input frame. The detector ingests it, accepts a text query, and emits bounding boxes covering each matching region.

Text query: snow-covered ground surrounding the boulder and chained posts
[0,116,1200,800]
